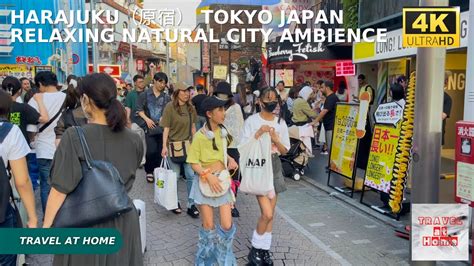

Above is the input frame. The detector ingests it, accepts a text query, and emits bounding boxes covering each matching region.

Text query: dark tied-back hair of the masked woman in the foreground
[77,73,127,132]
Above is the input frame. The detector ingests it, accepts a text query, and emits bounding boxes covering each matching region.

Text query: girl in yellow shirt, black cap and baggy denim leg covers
[187,97,237,265]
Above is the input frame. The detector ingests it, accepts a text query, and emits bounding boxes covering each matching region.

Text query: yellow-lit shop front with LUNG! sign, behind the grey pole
[353,11,469,200]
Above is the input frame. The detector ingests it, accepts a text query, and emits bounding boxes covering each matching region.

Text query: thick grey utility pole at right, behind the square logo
[410,0,448,265]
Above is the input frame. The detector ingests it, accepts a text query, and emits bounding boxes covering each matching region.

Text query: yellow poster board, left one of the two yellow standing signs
[330,104,359,178]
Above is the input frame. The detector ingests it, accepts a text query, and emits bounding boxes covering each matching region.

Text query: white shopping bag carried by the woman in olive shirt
[153,158,178,210]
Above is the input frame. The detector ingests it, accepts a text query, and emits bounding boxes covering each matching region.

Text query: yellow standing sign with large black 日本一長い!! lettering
[364,122,402,193]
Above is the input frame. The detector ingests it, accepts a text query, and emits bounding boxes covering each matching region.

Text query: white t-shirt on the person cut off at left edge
[0,122,30,167]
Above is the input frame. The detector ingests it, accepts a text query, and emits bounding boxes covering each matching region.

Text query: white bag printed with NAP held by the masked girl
[238,133,274,196]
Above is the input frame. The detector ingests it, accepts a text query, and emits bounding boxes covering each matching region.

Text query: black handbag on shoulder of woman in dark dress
[53,127,133,227]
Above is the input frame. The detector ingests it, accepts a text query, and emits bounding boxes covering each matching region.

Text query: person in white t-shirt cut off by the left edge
[0,90,38,265]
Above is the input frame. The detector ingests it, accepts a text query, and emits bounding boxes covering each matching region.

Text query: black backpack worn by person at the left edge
[0,122,13,223]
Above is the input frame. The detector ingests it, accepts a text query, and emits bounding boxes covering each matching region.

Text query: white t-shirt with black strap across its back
[27,91,66,160]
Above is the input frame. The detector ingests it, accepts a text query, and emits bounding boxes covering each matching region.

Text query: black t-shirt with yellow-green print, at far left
[10,102,40,144]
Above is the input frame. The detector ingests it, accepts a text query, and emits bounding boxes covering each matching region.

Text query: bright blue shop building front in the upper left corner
[0,0,88,81]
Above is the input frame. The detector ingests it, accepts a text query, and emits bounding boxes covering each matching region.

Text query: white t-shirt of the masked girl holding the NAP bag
[240,113,291,153]
